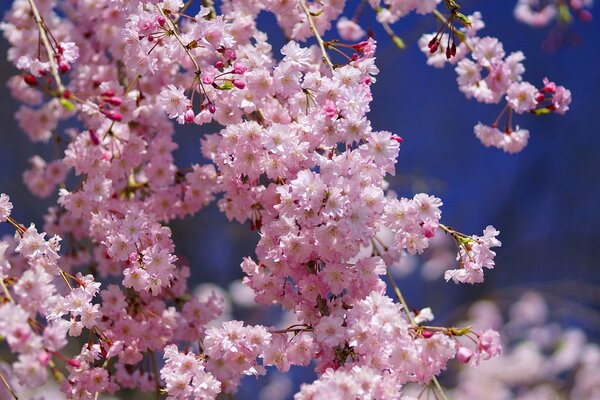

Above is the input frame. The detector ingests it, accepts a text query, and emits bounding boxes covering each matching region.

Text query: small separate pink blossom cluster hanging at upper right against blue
[419,13,571,153]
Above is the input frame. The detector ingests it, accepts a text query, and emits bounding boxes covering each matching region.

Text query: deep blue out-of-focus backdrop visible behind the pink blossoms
[0,0,600,399]
